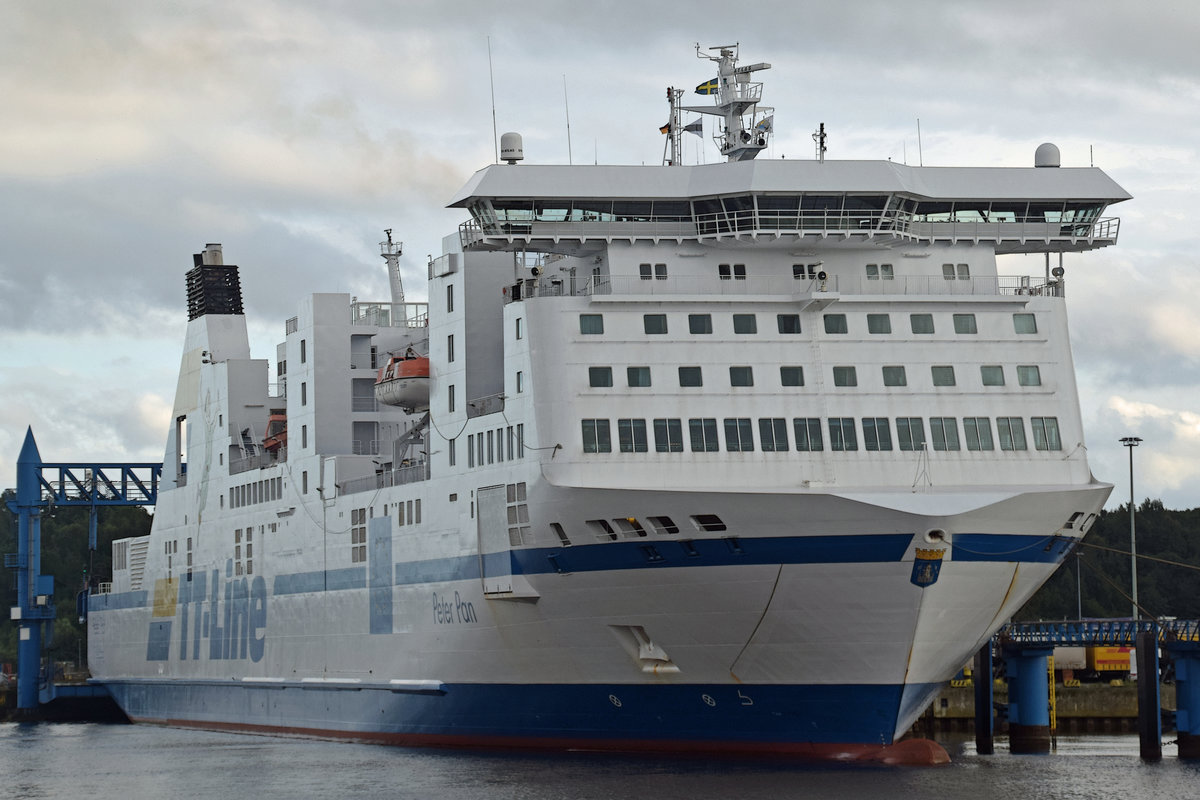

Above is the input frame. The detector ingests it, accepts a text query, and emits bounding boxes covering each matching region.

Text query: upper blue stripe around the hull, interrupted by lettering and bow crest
[89,534,1075,610]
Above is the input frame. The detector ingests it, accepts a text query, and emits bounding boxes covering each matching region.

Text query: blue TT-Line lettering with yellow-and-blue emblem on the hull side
[146,560,266,661]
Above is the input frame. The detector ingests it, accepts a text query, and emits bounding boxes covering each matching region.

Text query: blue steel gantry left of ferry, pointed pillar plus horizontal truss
[4,428,162,711]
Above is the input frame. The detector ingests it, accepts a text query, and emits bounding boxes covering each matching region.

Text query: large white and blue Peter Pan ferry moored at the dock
[88,46,1129,763]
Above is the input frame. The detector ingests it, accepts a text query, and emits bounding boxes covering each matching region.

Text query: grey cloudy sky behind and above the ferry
[0,0,1200,507]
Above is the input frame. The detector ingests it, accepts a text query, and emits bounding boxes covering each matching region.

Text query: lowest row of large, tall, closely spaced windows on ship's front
[582,416,1062,453]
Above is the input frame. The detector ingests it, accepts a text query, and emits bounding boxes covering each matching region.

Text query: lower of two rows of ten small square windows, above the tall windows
[588,365,1042,389]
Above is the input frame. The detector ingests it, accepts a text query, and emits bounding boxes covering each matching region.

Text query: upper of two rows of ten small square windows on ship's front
[580,312,1038,336]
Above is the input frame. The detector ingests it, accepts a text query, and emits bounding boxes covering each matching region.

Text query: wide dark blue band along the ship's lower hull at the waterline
[106,680,931,745]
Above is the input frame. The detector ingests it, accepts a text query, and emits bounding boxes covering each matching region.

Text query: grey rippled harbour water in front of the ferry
[0,723,1200,800]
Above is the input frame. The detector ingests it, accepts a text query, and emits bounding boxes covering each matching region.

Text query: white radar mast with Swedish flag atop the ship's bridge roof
[677,42,775,161]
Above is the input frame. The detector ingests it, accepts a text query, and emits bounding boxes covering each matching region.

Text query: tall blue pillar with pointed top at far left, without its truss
[5,428,54,712]
